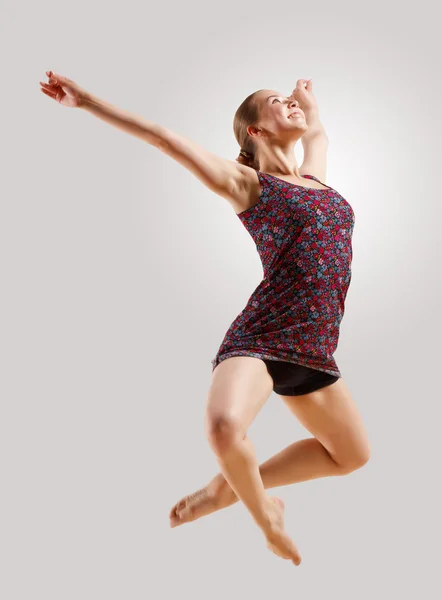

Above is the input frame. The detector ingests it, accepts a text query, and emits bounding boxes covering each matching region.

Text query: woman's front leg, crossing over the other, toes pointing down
[192,356,301,565]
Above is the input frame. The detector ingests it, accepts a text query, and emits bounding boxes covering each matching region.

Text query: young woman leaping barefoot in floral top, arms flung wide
[40,71,370,565]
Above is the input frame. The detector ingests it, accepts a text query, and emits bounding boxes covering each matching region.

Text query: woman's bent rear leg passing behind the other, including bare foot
[170,378,370,526]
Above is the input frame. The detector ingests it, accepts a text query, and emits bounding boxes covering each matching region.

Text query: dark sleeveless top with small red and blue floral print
[211,171,355,377]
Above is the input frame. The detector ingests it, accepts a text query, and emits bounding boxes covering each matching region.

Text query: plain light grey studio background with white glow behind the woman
[0,1,442,600]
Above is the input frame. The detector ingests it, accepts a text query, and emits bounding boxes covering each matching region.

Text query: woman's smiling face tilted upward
[251,90,308,140]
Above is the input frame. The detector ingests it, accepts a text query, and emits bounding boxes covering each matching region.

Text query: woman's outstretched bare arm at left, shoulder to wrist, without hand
[78,92,249,204]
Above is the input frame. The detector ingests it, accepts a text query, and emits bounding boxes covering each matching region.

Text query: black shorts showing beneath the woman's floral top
[262,358,339,396]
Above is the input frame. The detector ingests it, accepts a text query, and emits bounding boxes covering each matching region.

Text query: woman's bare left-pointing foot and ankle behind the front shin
[169,474,238,527]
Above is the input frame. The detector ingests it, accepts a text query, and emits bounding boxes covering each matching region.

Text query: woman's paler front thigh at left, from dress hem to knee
[205,356,273,435]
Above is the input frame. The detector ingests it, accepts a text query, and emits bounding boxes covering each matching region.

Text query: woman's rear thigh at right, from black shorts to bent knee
[281,377,370,468]
